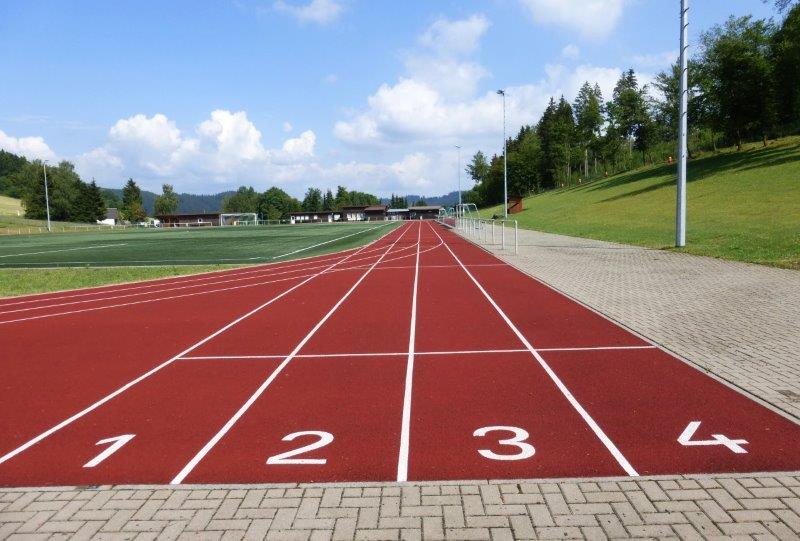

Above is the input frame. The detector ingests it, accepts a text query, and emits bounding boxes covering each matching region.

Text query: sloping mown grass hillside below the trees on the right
[481,137,800,269]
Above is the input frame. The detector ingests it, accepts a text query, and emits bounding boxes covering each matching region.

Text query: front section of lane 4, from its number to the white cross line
[544,349,800,475]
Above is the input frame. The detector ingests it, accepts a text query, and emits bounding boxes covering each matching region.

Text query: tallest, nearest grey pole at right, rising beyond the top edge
[675,0,689,248]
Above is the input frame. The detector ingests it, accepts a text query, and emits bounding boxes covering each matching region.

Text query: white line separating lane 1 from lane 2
[170,221,416,485]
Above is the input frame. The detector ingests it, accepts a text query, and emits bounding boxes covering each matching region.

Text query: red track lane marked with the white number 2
[173,224,421,483]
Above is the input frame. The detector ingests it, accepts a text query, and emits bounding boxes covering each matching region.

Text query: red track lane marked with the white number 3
[408,221,625,480]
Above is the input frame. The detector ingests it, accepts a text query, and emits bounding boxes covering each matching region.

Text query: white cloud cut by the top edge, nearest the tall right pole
[519,0,628,39]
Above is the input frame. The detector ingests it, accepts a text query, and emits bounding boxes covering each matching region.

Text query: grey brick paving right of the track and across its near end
[0,231,800,540]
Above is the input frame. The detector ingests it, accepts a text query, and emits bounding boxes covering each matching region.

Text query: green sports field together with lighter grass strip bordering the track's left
[0,222,397,297]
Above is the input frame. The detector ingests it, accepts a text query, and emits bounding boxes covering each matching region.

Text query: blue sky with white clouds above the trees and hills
[0,0,775,195]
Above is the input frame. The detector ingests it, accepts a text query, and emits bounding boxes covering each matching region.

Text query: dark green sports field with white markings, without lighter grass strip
[0,222,395,268]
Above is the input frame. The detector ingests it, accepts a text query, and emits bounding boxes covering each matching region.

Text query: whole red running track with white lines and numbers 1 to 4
[0,222,800,486]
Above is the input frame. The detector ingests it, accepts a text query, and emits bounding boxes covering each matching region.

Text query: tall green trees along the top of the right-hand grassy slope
[464,7,800,205]
